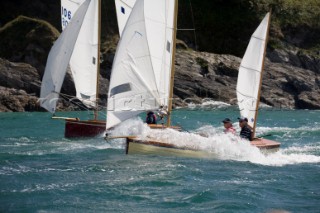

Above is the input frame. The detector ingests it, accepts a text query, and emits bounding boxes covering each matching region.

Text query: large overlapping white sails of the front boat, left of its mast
[107,0,175,129]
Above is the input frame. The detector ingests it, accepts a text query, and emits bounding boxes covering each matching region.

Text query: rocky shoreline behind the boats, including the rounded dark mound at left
[0,13,320,112]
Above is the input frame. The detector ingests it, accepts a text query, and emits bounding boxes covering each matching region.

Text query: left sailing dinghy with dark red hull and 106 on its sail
[40,0,106,137]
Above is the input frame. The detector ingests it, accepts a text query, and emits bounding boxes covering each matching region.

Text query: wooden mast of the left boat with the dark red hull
[94,0,101,120]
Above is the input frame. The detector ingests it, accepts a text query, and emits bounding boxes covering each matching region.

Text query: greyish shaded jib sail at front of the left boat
[40,0,91,113]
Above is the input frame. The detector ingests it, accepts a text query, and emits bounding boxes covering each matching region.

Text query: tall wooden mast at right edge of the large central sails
[167,0,178,127]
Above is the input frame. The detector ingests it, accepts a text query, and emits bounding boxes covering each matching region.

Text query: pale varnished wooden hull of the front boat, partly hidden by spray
[126,137,280,158]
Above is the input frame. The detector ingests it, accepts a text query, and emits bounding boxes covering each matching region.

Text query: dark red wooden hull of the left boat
[64,119,106,138]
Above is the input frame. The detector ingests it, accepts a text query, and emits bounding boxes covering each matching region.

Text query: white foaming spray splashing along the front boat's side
[112,119,320,166]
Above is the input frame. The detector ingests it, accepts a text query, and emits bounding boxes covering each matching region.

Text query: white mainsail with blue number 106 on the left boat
[61,0,100,107]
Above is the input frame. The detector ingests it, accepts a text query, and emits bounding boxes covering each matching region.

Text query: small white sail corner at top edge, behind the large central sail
[115,0,136,36]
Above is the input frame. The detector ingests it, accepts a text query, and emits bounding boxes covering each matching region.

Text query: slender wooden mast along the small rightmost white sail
[252,10,272,138]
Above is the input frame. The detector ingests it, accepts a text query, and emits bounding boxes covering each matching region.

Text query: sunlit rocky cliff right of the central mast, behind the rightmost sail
[174,47,320,109]
